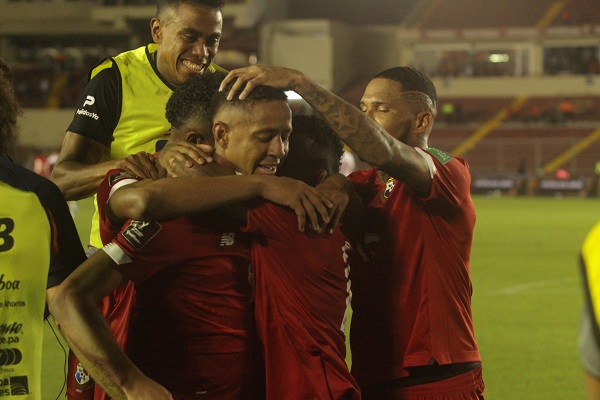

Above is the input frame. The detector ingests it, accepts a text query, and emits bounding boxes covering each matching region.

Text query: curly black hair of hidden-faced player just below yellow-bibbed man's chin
[165,72,226,128]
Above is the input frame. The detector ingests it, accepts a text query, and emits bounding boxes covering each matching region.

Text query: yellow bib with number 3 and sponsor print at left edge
[0,182,52,400]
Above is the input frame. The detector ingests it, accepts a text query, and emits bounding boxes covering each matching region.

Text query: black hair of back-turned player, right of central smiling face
[277,115,344,185]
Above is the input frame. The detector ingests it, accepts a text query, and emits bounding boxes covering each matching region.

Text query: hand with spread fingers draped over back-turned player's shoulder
[262,177,333,232]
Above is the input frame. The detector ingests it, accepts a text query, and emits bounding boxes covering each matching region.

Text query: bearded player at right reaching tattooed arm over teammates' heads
[221,66,484,399]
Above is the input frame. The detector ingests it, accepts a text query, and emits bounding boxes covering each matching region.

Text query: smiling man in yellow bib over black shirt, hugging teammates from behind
[52,0,224,398]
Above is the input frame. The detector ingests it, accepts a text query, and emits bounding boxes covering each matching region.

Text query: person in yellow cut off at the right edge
[579,220,600,400]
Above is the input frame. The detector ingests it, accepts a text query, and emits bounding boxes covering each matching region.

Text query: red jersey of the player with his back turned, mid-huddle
[245,202,360,399]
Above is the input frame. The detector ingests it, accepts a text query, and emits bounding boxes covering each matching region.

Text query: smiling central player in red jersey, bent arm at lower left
[50,83,332,399]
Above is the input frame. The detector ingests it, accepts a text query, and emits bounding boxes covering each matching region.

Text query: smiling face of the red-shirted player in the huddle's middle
[213,100,292,175]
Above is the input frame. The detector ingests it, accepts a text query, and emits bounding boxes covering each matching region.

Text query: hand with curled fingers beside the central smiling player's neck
[158,141,214,176]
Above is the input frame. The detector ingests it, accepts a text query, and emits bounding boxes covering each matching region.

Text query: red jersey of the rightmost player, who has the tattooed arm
[349,149,481,387]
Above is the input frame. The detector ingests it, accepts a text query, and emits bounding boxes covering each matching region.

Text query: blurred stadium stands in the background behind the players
[0,0,600,194]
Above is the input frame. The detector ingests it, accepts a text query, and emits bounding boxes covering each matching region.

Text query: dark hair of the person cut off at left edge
[0,59,19,154]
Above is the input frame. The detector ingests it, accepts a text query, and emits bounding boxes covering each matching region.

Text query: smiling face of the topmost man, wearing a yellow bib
[150,3,223,85]
